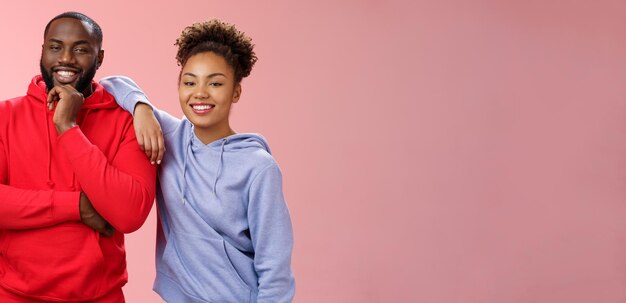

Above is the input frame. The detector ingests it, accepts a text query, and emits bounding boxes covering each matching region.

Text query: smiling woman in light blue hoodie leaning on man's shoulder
[101,20,295,302]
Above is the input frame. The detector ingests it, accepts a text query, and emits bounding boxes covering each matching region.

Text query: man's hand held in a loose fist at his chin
[48,85,85,135]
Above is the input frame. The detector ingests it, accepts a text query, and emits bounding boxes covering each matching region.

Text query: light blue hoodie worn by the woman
[100,77,295,303]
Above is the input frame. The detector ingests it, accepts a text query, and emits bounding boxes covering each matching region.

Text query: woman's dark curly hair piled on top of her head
[174,19,258,83]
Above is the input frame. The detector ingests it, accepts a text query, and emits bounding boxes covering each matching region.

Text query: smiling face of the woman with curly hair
[178,52,241,137]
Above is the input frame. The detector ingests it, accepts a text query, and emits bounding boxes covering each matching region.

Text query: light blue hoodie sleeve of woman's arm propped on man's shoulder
[100,76,180,134]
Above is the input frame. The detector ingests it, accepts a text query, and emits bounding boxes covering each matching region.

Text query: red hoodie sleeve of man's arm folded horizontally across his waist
[0,132,80,229]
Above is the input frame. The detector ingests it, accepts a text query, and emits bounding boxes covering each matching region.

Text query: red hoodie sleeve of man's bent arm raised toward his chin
[57,119,156,233]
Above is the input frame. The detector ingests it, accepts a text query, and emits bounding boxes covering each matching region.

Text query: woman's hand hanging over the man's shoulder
[133,103,165,164]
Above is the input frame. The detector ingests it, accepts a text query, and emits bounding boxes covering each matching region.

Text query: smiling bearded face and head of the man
[39,18,104,96]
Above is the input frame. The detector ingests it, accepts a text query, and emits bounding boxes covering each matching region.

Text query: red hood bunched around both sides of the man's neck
[27,75,118,109]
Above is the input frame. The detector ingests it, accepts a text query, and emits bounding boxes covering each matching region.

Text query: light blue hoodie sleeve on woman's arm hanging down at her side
[248,163,295,303]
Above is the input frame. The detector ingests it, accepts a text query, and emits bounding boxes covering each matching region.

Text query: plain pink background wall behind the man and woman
[0,0,626,303]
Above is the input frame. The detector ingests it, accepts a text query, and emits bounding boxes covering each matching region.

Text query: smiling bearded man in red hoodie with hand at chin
[0,12,156,303]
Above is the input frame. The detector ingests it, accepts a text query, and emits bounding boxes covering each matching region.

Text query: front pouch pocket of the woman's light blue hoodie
[162,231,251,303]
